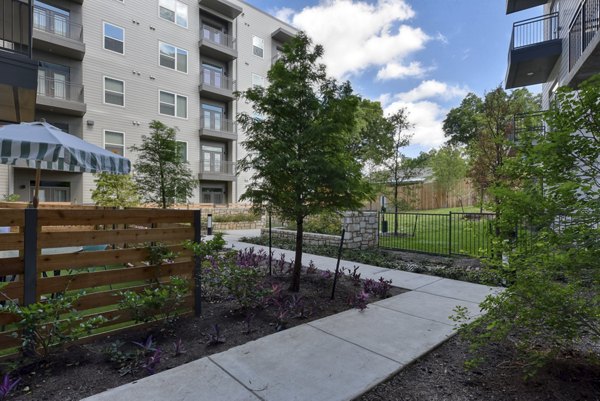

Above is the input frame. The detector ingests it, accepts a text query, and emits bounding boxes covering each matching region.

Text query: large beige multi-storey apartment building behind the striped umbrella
[0,0,296,204]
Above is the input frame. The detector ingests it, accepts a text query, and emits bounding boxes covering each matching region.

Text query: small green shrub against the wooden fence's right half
[118,276,190,324]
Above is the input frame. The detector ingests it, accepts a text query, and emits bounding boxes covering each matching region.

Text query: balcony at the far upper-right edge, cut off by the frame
[566,0,600,87]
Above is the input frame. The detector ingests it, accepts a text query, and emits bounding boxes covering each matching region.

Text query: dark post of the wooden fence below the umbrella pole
[23,208,38,305]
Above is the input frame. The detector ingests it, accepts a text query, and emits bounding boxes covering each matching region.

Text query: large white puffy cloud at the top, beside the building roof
[276,0,432,78]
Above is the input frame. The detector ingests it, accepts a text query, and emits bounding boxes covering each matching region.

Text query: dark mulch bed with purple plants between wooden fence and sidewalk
[5,273,405,401]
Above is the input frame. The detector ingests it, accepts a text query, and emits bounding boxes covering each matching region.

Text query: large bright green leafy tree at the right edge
[466,77,600,374]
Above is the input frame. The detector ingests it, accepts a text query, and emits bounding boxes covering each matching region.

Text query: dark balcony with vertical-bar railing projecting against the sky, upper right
[506,13,562,89]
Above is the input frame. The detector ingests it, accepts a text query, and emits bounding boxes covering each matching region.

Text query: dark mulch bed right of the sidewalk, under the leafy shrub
[356,336,600,401]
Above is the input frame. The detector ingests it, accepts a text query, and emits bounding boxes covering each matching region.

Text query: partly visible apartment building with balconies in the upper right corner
[506,0,600,109]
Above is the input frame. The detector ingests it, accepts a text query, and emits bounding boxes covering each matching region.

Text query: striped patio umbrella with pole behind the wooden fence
[0,122,131,207]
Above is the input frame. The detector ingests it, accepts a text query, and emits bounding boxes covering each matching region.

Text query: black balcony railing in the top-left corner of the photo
[0,0,31,58]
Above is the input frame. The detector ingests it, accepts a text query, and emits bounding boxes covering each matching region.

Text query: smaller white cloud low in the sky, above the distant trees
[383,80,468,149]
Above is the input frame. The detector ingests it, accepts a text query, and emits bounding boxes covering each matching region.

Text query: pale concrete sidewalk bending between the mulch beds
[85,231,498,401]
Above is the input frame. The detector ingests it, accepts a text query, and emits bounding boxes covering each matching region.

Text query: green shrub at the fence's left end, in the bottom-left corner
[0,292,107,358]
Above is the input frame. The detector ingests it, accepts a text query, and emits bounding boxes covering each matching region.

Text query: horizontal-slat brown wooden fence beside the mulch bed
[0,209,201,353]
